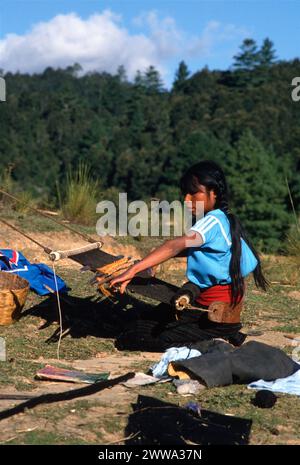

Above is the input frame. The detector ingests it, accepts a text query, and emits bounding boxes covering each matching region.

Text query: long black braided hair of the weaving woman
[180,161,269,305]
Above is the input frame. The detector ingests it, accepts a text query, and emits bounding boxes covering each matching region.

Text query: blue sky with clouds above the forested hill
[0,0,300,86]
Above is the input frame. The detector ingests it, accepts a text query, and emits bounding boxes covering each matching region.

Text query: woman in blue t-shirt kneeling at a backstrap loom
[110,161,267,351]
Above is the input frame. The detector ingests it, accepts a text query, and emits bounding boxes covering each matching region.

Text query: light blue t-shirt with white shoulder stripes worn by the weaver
[187,209,258,288]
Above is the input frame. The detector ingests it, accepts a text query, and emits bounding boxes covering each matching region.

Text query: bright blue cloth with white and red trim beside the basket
[0,249,68,295]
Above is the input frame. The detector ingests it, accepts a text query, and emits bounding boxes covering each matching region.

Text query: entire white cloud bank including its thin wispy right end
[0,10,248,78]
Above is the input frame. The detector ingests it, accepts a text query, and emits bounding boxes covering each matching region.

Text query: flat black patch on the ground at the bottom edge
[125,395,252,445]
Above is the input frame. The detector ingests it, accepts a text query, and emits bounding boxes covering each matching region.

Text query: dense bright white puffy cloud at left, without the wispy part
[0,10,162,77]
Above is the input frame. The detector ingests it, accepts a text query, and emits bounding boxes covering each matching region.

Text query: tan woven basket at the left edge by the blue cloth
[0,271,29,325]
